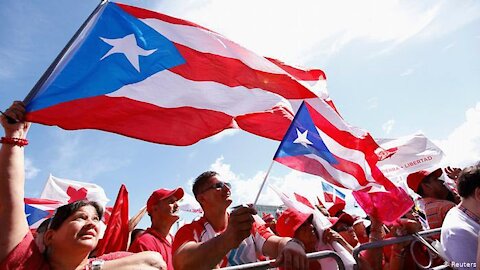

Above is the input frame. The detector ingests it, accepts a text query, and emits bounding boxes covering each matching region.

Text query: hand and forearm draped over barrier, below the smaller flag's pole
[262,235,309,269]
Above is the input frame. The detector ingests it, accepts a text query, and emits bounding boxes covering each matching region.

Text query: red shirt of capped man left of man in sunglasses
[128,228,173,270]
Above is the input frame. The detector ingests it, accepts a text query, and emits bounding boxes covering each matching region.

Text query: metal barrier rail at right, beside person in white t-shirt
[353,228,449,270]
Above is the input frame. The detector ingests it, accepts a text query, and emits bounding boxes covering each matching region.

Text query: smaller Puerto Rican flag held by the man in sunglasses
[274,100,413,223]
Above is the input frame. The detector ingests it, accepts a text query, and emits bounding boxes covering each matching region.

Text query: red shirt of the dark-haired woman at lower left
[0,231,131,270]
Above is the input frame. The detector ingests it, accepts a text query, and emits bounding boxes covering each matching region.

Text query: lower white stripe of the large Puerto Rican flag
[107,70,292,116]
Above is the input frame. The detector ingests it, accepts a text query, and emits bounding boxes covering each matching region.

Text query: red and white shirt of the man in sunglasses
[172,217,273,267]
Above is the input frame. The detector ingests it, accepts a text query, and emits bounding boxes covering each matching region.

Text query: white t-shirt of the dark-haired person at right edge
[441,207,480,269]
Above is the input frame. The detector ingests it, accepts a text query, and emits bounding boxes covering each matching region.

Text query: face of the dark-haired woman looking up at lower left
[45,205,100,252]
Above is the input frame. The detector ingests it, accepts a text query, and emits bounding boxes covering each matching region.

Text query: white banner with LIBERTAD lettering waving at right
[375,133,444,178]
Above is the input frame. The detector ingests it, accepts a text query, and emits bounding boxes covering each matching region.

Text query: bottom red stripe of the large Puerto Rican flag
[27,96,292,145]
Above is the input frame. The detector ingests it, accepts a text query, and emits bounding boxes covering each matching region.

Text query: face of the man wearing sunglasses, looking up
[198,176,232,210]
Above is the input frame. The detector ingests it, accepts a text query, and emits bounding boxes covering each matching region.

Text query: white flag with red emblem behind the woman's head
[40,175,109,207]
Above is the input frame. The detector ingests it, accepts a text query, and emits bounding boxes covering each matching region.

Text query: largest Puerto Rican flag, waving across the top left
[26,2,328,145]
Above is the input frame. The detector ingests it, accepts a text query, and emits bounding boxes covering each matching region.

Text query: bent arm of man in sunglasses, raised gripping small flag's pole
[173,207,256,270]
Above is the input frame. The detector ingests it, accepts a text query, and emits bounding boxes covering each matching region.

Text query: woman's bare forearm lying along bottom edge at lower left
[102,251,167,270]
